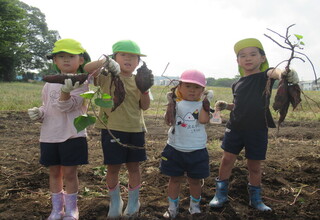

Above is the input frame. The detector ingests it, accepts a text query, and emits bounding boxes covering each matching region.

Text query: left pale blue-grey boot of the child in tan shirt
[108,184,123,219]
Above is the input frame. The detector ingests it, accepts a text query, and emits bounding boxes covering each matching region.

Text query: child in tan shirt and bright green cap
[85,40,150,218]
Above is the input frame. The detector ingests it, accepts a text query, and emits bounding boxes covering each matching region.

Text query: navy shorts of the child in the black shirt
[221,128,268,160]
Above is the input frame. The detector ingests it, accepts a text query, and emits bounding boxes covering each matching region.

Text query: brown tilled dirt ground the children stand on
[0,112,320,220]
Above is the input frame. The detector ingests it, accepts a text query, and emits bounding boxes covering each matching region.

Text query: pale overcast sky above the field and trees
[22,0,320,80]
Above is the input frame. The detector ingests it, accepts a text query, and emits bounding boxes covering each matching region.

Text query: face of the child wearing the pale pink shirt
[53,52,84,73]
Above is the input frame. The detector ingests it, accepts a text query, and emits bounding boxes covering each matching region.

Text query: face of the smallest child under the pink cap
[178,82,204,101]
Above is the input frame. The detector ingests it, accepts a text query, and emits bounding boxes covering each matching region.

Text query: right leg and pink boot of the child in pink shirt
[63,166,79,220]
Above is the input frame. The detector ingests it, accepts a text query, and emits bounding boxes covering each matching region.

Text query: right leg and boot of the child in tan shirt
[124,162,141,217]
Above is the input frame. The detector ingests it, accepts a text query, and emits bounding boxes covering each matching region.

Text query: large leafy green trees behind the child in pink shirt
[0,0,60,82]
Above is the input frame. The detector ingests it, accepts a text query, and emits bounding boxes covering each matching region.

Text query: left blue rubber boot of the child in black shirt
[209,178,229,208]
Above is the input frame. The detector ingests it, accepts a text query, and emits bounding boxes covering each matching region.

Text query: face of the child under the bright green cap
[115,52,139,75]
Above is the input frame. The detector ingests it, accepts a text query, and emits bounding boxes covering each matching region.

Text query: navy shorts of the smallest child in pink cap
[160,144,210,179]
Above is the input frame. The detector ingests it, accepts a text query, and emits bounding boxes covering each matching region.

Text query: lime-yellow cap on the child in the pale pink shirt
[52,39,86,54]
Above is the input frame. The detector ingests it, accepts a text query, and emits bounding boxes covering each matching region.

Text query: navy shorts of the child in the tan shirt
[101,129,147,164]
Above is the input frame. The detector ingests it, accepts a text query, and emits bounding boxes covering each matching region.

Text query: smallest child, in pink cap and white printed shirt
[160,70,213,218]
